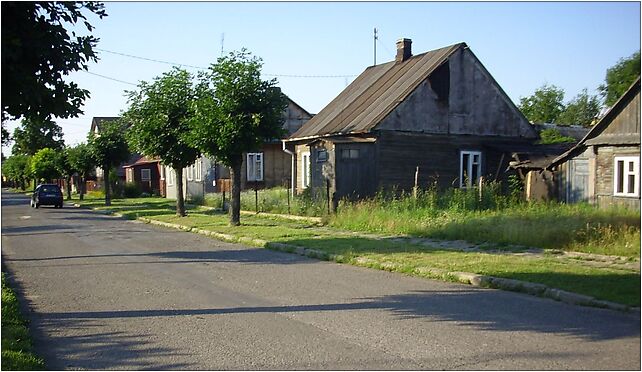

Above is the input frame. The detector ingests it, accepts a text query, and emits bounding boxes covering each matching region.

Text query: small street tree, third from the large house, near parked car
[87,120,129,206]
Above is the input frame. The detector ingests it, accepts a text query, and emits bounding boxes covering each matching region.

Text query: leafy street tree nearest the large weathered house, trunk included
[191,49,287,226]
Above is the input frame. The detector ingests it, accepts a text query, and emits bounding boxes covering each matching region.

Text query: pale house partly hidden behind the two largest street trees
[161,98,312,199]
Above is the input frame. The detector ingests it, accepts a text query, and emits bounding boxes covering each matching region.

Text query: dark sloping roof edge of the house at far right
[546,77,640,169]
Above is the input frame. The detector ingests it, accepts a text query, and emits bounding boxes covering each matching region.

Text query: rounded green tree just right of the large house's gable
[519,84,564,123]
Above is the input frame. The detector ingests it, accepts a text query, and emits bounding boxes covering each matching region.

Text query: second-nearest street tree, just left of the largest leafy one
[123,68,201,217]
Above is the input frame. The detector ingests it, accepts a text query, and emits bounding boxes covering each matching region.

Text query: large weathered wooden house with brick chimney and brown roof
[283,39,538,202]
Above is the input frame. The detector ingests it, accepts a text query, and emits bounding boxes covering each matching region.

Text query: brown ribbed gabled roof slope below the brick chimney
[286,43,467,141]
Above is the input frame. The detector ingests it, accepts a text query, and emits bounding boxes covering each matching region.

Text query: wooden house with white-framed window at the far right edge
[547,78,640,209]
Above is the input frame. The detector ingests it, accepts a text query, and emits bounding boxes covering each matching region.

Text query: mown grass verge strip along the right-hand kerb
[74,198,640,306]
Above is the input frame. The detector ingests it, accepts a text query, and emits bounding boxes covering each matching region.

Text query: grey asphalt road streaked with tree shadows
[2,192,640,370]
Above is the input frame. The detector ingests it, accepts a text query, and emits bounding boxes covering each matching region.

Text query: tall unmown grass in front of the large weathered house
[330,184,640,257]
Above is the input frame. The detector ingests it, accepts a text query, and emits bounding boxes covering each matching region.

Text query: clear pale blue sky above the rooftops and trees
[3,2,640,154]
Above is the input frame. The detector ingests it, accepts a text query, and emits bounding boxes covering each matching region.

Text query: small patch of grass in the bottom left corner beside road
[2,272,45,371]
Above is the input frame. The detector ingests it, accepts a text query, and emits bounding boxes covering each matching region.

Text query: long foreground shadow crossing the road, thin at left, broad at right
[37,290,640,341]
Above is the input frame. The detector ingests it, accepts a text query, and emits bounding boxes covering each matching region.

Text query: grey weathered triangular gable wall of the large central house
[375,49,537,139]
